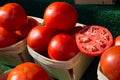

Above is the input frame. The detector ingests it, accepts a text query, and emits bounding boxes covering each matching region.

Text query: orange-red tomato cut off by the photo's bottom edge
[7,62,51,80]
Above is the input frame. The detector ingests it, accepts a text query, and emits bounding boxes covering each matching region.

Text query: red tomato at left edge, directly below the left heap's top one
[0,27,19,48]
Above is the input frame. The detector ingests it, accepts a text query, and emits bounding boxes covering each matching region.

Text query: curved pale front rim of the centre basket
[27,45,81,69]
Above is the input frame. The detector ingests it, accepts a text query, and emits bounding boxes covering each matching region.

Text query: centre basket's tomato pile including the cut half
[27,2,113,61]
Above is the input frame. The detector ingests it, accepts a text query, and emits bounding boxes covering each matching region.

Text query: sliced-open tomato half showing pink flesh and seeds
[75,25,113,56]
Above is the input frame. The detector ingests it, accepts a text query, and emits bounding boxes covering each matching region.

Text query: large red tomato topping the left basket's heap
[0,3,27,31]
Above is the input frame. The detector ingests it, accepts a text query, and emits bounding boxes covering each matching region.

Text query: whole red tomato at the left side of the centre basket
[27,25,54,52]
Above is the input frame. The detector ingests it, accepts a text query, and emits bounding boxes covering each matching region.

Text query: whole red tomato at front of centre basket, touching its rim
[48,34,79,61]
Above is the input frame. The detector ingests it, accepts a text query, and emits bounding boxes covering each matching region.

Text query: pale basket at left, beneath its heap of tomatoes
[0,39,32,66]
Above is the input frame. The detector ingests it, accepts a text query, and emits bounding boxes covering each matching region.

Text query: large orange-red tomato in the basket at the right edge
[100,46,120,80]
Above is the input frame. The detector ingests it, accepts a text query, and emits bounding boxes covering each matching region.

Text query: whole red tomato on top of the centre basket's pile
[43,2,78,31]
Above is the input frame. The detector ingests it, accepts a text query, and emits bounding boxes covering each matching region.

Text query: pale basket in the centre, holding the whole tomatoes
[27,46,93,80]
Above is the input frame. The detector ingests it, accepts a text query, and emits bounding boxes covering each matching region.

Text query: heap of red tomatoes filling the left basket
[0,3,38,48]
